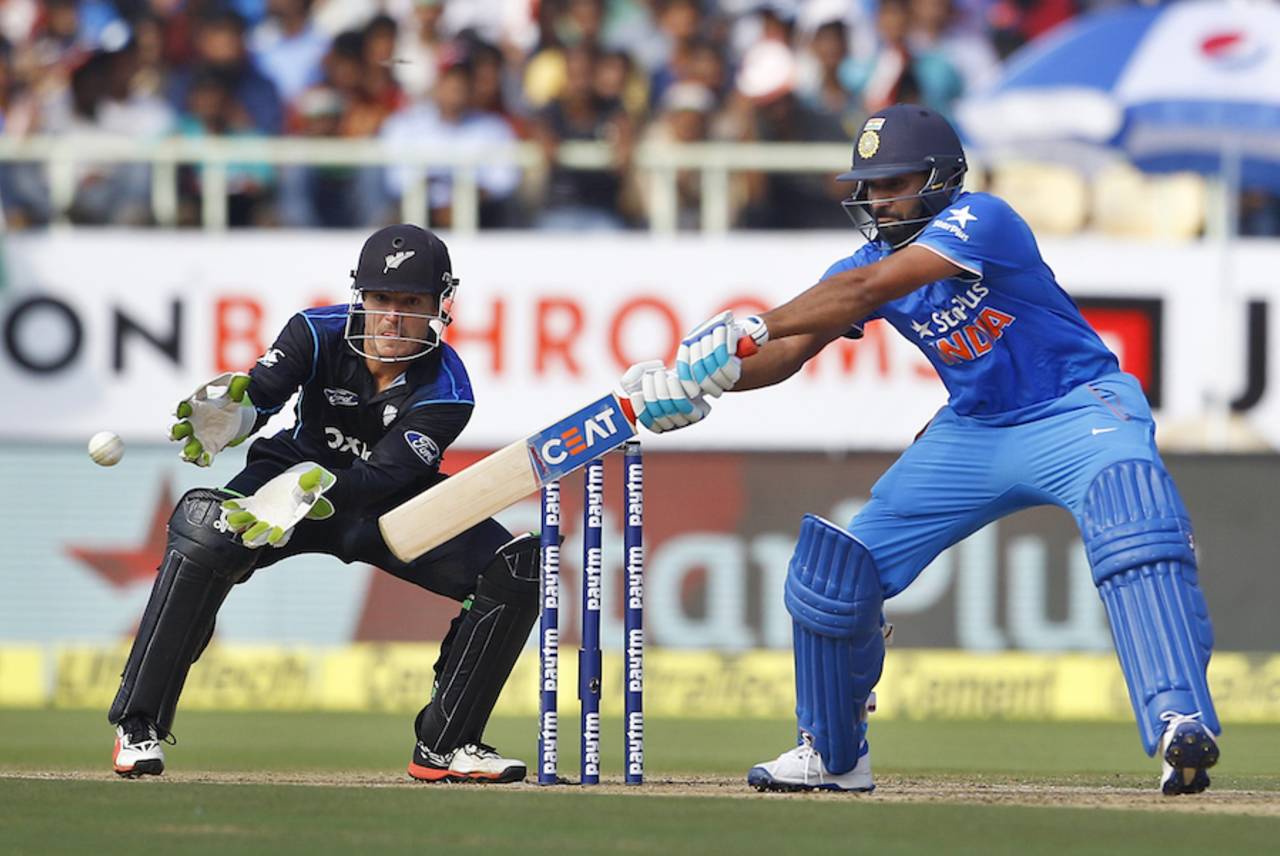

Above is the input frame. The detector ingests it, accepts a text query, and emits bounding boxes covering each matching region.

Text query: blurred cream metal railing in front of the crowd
[0,136,850,233]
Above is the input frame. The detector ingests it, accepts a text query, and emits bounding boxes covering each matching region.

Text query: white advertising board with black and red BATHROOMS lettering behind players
[0,230,1280,449]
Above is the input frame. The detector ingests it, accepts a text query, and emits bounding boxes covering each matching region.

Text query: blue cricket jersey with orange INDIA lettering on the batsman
[823,193,1120,416]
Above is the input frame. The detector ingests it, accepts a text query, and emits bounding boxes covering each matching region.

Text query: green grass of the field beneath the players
[0,711,1280,856]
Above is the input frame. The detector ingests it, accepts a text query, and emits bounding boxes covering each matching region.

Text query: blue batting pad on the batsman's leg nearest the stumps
[786,514,884,774]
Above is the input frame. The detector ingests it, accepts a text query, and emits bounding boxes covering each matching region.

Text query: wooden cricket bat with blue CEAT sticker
[378,337,759,562]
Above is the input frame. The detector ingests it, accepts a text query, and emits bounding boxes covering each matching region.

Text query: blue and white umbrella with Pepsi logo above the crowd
[956,0,1280,188]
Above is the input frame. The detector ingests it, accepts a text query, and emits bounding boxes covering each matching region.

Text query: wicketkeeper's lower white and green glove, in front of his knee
[221,462,338,546]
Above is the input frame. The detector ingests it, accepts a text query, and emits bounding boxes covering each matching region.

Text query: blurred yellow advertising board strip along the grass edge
[0,644,1280,723]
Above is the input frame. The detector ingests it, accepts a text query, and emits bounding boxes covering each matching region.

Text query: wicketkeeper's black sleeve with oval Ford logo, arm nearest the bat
[325,403,472,512]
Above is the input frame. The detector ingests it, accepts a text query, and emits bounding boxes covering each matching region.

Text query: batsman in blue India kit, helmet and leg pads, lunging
[623,105,1221,795]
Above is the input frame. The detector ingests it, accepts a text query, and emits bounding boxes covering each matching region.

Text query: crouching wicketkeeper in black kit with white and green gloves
[109,225,539,782]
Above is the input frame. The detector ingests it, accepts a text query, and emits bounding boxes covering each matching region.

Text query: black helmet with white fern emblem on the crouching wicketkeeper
[346,223,458,362]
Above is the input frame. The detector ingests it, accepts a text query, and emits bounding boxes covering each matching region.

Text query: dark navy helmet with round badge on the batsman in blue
[836,104,969,250]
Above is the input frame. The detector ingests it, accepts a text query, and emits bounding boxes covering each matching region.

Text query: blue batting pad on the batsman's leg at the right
[1082,461,1221,755]
